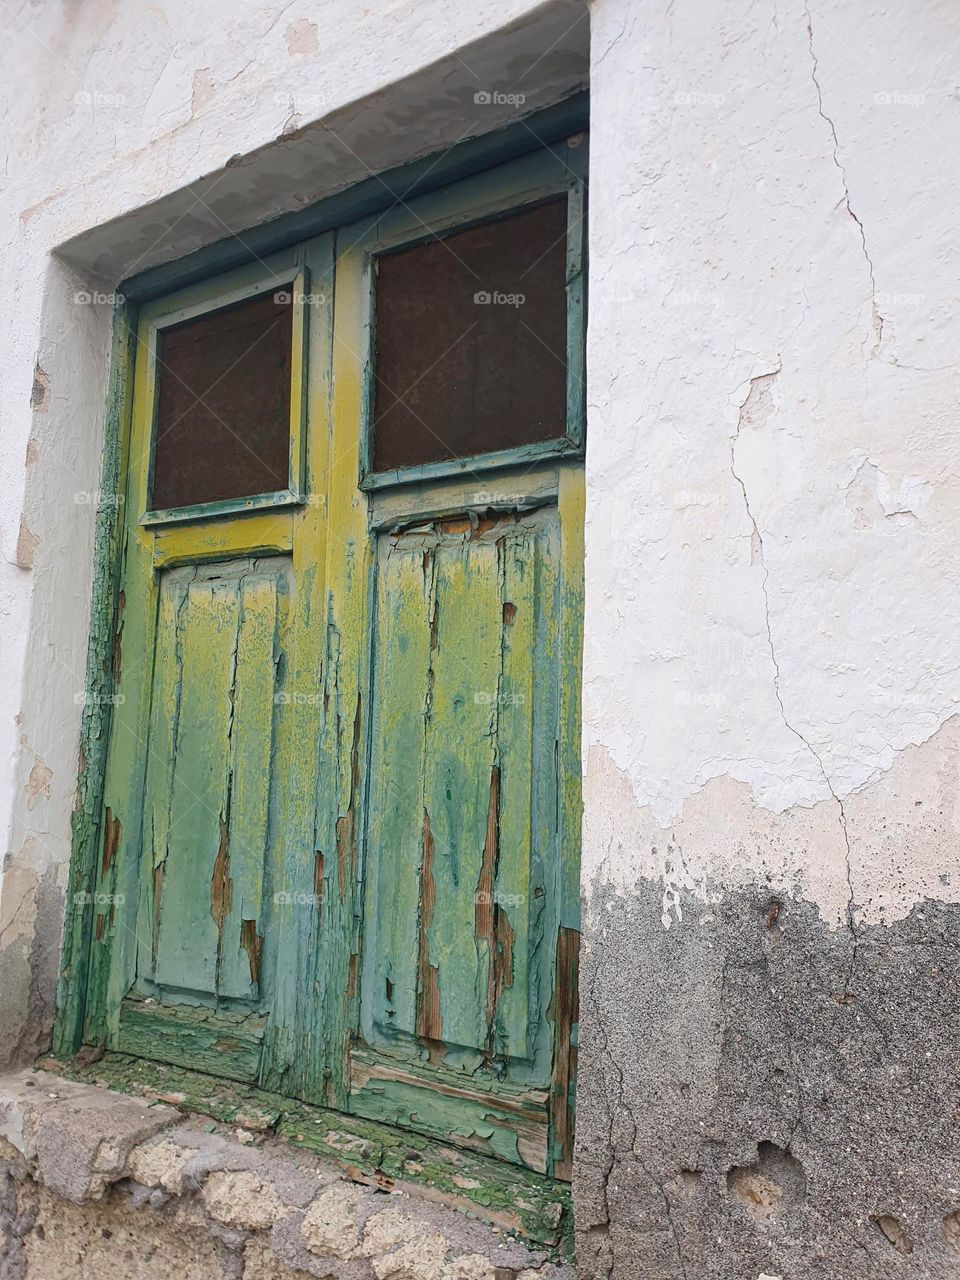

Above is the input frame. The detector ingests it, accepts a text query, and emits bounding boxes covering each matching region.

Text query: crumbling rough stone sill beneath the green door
[0,1070,575,1280]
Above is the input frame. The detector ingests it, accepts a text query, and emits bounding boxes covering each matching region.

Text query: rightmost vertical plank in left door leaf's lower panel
[216,570,287,1000]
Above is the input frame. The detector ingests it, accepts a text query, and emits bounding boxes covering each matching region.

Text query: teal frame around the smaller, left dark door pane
[140,253,310,525]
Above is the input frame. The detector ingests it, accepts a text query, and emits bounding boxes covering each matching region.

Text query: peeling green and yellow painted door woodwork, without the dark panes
[56,140,591,1212]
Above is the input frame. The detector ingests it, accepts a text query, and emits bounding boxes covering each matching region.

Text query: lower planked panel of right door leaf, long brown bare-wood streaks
[352,508,561,1158]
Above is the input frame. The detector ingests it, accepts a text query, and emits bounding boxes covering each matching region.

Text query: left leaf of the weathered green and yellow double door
[86,244,312,1080]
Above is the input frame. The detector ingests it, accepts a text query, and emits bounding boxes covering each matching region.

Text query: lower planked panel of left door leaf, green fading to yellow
[138,557,289,1000]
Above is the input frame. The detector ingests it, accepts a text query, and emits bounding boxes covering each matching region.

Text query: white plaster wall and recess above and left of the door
[0,0,589,1059]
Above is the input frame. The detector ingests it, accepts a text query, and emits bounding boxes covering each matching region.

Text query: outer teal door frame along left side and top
[52,92,589,1059]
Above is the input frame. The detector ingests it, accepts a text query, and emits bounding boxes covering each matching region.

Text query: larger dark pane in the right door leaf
[374,200,567,471]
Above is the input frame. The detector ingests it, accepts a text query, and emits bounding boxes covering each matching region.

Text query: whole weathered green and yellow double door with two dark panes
[80,140,585,1176]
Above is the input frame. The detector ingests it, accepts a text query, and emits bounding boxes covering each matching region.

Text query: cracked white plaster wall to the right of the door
[584,0,960,925]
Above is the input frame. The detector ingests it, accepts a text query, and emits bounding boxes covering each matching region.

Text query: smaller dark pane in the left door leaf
[151,292,293,511]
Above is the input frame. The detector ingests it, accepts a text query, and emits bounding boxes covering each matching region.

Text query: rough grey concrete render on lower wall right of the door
[575,886,960,1280]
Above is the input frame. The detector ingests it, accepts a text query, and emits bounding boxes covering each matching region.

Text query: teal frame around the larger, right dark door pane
[358,134,589,492]
